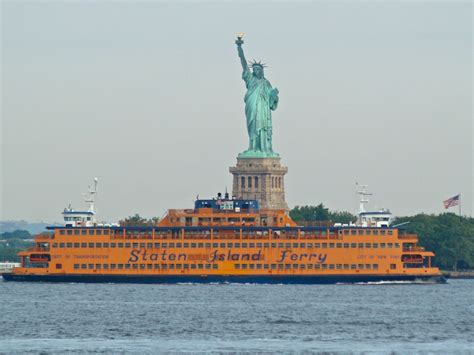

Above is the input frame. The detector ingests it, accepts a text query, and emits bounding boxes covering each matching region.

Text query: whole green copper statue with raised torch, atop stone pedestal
[235,34,278,158]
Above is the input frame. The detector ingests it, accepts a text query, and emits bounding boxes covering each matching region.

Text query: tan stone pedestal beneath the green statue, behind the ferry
[229,157,288,211]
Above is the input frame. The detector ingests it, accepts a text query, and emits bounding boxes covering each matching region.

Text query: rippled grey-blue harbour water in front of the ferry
[0,280,474,354]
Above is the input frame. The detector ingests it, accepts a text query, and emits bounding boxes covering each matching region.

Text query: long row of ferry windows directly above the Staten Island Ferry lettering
[53,243,400,249]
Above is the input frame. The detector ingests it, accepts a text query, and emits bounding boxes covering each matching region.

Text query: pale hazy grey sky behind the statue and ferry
[0,1,473,222]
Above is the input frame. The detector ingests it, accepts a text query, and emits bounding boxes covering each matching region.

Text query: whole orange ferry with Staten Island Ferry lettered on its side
[3,181,445,284]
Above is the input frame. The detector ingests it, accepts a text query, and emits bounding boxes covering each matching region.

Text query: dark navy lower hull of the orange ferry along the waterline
[2,273,446,285]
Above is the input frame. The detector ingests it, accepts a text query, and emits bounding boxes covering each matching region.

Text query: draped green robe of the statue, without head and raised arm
[242,70,278,152]
